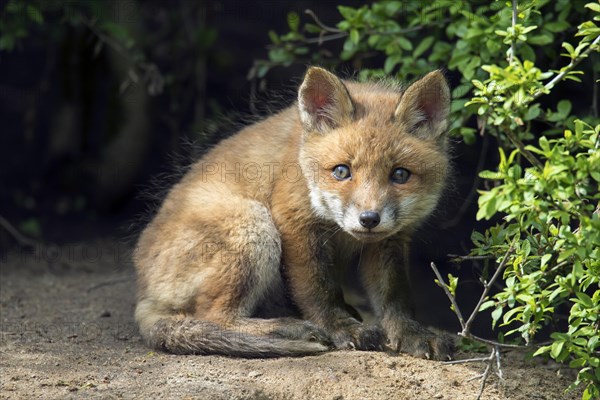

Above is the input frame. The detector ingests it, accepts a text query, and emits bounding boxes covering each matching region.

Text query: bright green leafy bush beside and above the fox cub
[250,0,600,399]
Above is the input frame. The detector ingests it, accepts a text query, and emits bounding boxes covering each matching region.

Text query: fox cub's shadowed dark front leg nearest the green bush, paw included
[361,240,454,360]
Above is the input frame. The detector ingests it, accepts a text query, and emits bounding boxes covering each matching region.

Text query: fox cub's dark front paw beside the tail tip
[332,318,385,350]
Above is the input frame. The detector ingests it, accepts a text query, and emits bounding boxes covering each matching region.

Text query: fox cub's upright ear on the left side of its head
[298,67,354,133]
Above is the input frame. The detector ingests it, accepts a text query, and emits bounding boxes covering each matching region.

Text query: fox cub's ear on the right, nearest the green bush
[394,71,450,139]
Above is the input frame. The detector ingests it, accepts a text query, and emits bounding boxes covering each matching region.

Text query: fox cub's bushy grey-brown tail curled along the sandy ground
[143,318,329,358]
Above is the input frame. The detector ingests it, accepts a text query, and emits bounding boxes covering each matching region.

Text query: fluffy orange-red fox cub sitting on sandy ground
[134,67,453,360]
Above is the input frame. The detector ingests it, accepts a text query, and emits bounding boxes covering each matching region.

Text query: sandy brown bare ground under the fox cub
[0,241,581,400]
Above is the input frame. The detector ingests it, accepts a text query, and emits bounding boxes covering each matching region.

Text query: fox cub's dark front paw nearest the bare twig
[388,321,455,361]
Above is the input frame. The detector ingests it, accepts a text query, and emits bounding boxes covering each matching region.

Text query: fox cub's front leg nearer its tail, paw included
[282,225,385,350]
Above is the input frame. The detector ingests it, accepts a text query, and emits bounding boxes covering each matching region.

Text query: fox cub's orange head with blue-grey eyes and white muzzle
[298,67,450,242]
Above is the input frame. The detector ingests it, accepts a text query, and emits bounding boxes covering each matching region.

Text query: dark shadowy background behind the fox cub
[0,0,495,333]
